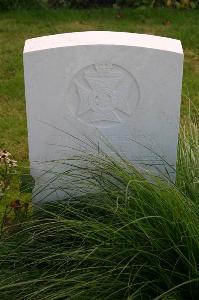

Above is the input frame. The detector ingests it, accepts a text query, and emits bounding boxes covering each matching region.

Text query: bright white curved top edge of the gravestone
[24,31,183,54]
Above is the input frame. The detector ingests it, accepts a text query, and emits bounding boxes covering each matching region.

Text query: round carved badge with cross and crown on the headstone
[70,63,139,127]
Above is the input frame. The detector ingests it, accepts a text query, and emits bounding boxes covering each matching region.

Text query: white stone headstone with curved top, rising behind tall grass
[24,31,183,202]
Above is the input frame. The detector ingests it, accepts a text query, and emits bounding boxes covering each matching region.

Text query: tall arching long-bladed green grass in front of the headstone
[0,116,199,300]
